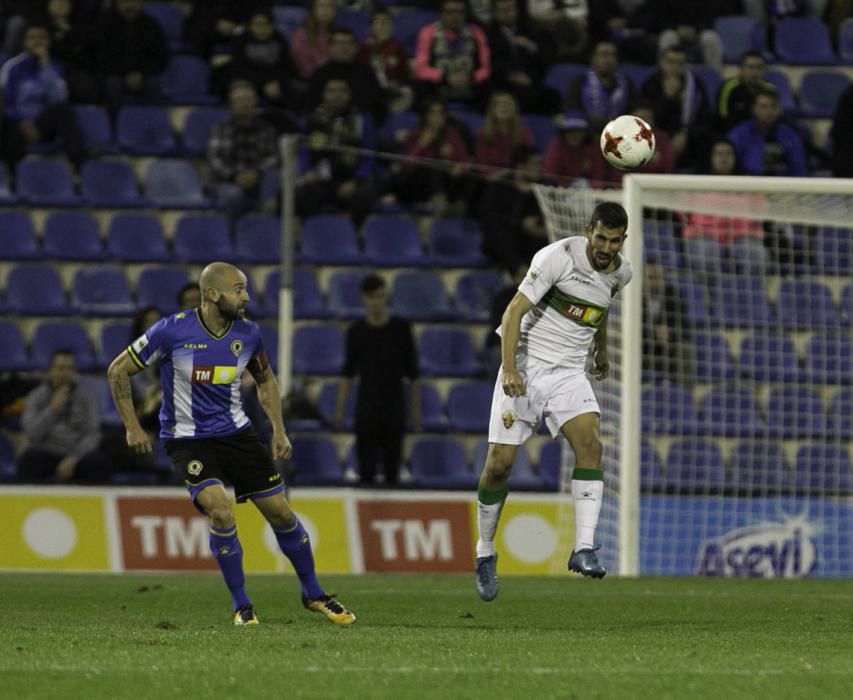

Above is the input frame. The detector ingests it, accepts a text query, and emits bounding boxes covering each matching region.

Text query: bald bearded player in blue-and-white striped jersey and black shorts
[107,262,355,625]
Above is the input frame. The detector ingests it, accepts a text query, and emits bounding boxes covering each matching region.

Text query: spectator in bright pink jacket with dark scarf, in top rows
[415,0,492,107]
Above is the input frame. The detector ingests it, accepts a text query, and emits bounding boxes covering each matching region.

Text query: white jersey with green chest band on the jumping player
[498,236,632,372]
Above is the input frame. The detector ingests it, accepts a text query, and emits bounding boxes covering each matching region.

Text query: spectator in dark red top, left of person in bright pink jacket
[358,8,412,112]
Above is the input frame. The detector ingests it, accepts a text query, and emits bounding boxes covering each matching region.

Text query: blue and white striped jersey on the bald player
[127,309,267,439]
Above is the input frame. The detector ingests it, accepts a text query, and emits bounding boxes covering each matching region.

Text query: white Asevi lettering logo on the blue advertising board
[698,515,817,578]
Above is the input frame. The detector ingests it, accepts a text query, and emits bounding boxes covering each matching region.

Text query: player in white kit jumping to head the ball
[476,202,631,600]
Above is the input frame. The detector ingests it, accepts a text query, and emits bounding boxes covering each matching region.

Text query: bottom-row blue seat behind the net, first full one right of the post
[664,438,727,494]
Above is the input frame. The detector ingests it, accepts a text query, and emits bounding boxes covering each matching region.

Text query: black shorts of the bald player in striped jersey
[163,427,284,503]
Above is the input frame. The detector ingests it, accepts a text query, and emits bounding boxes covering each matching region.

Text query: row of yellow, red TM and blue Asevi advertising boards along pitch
[0,486,853,578]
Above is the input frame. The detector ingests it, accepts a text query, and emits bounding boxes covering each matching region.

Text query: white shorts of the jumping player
[489,354,601,445]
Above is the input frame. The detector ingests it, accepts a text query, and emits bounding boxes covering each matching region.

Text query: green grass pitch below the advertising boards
[0,573,853,700]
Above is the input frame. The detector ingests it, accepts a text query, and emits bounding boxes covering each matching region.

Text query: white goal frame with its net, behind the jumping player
[537,175,853,577]
